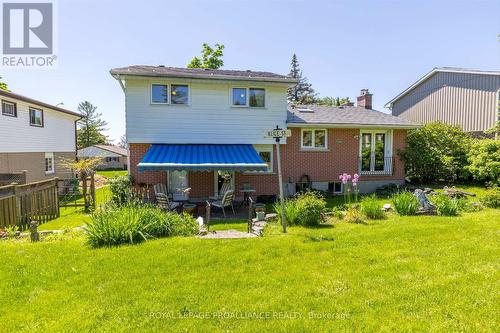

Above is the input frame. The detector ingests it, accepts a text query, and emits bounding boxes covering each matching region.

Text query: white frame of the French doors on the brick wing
[359,129,393,175]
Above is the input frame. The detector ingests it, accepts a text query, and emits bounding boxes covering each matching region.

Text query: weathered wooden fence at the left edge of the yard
[0,178,59,230]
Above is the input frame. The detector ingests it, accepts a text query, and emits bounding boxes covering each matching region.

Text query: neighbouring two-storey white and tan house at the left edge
[0,90,80,182]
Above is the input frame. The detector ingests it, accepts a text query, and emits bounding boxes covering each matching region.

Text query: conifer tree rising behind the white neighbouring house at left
[76,101,108,149]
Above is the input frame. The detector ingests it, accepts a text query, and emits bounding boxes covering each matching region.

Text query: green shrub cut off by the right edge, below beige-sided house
[468,139,500,184]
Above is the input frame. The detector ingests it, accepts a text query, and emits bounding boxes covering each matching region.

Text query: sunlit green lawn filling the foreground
[0,195,500,332]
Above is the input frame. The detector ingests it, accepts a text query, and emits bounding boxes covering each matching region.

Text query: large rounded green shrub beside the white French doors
[400,122,470,183]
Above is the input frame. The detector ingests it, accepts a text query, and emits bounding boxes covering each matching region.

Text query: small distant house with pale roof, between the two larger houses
[77,145,127,170]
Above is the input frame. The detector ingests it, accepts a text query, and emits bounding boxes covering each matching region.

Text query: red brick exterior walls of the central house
[129,128,406,198]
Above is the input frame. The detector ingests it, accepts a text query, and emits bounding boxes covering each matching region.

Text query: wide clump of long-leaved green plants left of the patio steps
[86,204,198,247]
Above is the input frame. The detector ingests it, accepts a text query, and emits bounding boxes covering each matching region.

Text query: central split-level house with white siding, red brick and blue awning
[111,66,416,200]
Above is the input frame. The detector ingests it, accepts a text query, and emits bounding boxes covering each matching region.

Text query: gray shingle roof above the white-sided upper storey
[110,65,297,83]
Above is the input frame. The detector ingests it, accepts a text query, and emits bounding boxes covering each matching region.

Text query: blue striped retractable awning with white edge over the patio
[137,144,267,172]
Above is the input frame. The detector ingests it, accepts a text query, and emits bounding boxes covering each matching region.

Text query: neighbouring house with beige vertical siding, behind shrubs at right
[385,67,500,132]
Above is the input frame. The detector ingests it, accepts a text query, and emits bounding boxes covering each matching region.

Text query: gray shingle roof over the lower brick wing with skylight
[287,105,419,128]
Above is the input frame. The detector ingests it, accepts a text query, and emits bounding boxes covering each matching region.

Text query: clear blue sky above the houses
[0,0,500,139]
